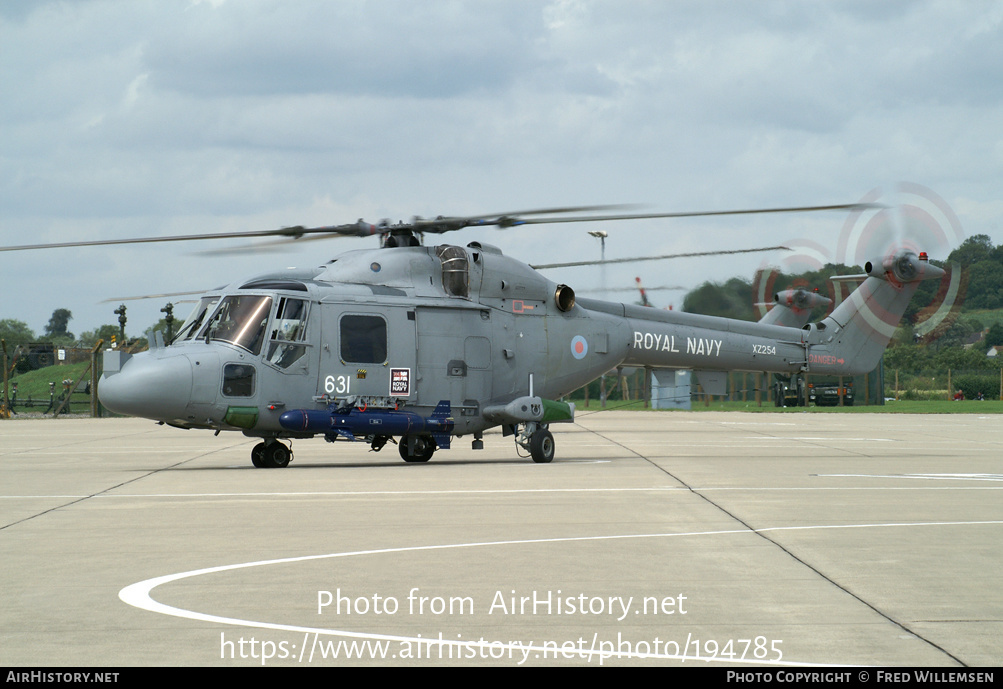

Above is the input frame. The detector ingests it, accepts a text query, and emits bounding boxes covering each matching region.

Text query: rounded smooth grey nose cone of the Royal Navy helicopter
[97,354,192,421]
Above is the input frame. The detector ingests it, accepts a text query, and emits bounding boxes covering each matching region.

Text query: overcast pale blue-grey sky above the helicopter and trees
[0,0,1003,335]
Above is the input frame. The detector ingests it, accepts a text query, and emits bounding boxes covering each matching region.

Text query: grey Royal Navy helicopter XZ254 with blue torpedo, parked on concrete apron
[1,205,943,467]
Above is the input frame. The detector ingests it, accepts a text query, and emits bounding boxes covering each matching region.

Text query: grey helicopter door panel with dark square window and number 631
[318,304,417,404]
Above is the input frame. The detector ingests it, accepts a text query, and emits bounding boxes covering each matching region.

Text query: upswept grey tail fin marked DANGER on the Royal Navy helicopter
[808,252,944,375]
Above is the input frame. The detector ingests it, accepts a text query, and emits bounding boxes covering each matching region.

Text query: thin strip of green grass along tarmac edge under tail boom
[571,399,1003,414]
